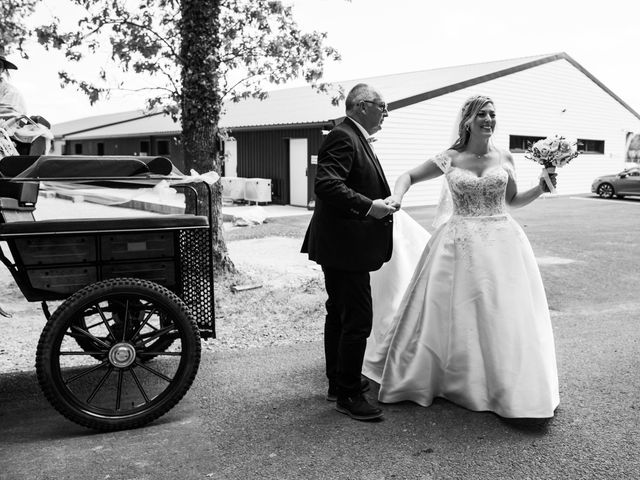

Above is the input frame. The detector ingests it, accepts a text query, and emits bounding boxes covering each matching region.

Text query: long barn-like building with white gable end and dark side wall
[54,53,640,206]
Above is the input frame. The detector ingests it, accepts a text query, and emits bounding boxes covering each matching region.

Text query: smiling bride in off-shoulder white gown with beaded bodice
[363,96,559,418]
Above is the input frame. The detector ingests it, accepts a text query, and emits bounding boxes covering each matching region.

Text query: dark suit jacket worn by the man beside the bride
[302,118,393,272]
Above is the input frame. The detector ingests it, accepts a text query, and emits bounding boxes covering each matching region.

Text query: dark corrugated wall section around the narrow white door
[230,127,323,205]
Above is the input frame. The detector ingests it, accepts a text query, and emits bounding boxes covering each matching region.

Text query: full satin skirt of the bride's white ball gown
[363,214,559,418]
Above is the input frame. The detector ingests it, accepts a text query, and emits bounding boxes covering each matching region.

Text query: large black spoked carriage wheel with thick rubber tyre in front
[36,278,200,430]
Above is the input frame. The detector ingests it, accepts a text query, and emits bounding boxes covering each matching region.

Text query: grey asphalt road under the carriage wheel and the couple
[0,193,640,480]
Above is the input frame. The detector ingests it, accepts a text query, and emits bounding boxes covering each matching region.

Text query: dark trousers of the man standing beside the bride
[322,266,373,396]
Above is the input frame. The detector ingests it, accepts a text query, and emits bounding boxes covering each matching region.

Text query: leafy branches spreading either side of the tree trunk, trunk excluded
[36,0,342,114]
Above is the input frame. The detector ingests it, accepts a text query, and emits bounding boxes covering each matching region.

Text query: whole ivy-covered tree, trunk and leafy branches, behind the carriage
[36,0,343,270]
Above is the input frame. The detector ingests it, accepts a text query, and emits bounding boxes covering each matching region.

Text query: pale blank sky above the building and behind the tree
[9,0,640,123]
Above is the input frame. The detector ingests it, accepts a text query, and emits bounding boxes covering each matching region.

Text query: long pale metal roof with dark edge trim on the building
[54,52,640,140]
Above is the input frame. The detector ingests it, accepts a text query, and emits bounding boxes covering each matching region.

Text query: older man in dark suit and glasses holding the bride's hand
[302,84,395,420]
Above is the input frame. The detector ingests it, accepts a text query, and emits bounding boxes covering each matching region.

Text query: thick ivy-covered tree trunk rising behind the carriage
[180,0,235,271]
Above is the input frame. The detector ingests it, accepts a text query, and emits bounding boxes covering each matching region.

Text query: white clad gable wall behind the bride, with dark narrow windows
[374,60,640,206]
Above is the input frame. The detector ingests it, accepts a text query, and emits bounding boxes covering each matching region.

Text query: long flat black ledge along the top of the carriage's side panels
[0,215,209,237]
